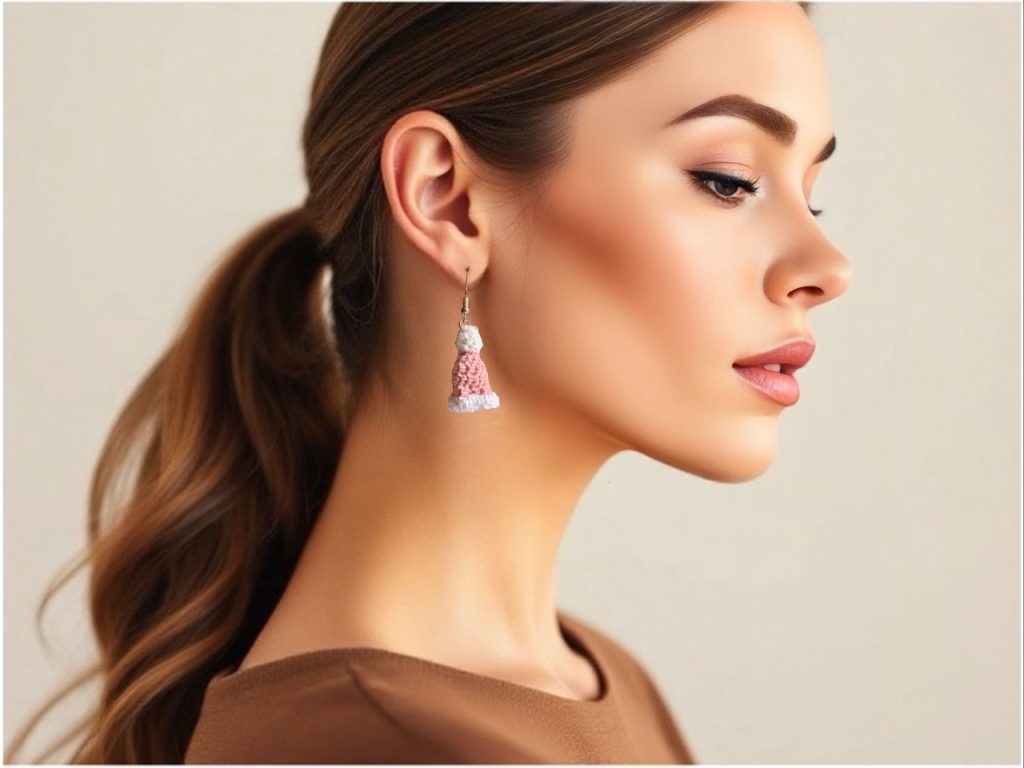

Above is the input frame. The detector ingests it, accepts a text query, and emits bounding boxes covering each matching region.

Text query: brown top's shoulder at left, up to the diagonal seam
[183,650,450,764]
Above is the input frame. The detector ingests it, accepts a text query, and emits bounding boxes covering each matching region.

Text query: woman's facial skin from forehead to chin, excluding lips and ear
[483,3,851,481]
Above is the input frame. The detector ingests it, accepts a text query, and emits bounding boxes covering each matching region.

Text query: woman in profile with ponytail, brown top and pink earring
[6,3,851,763]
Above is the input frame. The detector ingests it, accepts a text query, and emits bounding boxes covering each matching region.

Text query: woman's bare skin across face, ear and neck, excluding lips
[242,3,851,699]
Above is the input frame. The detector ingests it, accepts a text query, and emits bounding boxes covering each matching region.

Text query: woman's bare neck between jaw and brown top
[272,372,616,671]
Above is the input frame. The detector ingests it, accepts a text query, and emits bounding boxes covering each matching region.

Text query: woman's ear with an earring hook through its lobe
[380,110,490,287]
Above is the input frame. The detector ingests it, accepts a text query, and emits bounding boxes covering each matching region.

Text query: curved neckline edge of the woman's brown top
[203,610,613,710]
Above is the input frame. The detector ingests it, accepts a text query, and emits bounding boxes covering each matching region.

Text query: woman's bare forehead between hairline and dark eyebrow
[573,2,833,150]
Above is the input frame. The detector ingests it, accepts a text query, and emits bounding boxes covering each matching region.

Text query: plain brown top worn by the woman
[184,610,694,763]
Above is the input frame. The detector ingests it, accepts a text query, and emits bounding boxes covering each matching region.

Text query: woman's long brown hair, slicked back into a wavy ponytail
[6,2,806,763]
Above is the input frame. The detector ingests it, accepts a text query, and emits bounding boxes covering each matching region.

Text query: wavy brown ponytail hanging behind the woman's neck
[6,207,344,763]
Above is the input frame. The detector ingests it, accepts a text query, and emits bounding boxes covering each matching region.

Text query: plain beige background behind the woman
[4,3,1021,763]
